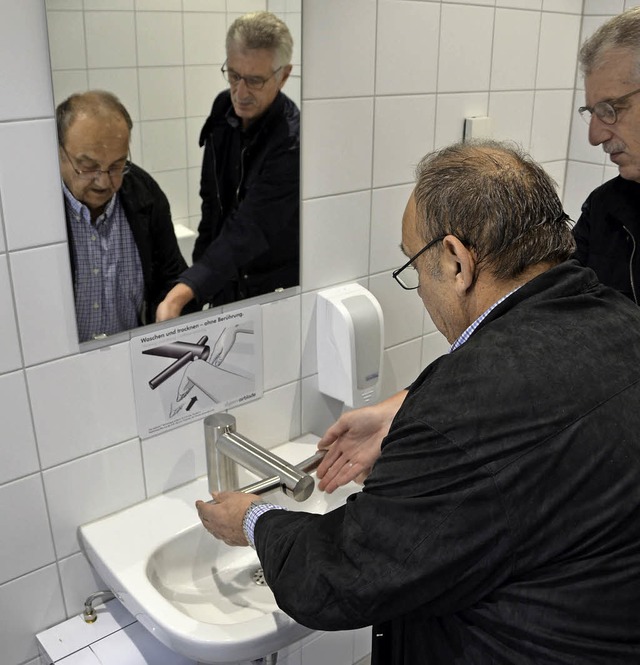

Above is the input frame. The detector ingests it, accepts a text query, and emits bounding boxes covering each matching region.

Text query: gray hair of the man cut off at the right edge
[578,7,640,76]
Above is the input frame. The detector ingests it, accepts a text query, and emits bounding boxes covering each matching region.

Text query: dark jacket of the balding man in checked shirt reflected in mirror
[67,164,187,325]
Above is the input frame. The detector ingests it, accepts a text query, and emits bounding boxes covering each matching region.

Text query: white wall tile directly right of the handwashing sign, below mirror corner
[262,296,300,390]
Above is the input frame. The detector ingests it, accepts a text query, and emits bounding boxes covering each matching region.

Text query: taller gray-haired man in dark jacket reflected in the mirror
[157,12,300,321]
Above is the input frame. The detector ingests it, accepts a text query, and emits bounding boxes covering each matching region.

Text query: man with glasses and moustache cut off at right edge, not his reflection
[574,7,640,304]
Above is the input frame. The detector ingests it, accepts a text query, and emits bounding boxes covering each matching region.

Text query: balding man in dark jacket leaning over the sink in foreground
[196,142,640,665]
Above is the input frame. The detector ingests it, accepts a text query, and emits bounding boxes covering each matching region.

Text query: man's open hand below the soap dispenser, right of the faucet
[317,390,407,494]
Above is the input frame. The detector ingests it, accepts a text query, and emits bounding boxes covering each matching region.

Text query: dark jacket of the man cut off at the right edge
[573,176,640,304]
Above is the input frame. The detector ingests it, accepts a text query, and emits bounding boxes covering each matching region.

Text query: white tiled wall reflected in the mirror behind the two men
[45,0,302,342]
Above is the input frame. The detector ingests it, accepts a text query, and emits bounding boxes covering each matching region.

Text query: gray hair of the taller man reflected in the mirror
[226,12,293,69]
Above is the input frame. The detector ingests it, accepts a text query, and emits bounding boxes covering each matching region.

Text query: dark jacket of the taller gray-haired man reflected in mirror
[180,90,300,305]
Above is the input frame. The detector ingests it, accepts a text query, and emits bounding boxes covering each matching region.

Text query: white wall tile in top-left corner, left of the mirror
[0,1,53,120]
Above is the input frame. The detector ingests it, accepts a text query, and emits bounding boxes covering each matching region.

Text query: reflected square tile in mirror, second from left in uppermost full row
[84,11,138,68]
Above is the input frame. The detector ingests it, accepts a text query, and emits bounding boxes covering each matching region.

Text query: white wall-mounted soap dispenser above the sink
[316,283,384,407]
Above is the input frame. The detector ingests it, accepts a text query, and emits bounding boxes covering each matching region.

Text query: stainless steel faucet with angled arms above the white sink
[204,413,325,501]
